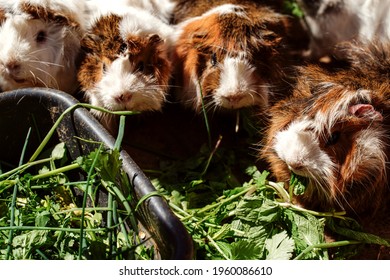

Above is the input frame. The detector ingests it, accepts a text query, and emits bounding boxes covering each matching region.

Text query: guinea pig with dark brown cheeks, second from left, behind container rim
[78,8,172,118]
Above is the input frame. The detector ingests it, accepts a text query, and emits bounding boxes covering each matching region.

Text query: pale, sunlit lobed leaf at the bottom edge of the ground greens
[265,231,295,260]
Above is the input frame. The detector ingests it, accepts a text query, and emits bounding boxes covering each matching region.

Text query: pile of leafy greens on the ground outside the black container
[151,115,390,260]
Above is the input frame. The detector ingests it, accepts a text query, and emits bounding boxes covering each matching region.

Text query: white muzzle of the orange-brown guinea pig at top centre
[213,54,268,109]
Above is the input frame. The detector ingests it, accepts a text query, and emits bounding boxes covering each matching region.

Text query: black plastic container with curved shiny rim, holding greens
[0,88,193,259]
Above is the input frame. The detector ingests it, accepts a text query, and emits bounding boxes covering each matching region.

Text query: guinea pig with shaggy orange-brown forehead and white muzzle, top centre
[173,0,296,112]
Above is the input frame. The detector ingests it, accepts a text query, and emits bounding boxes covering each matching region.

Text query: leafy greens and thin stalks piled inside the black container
[0,108,155,260]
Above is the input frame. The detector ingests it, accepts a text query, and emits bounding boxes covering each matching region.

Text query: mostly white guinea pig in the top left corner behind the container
[0,0,85,93]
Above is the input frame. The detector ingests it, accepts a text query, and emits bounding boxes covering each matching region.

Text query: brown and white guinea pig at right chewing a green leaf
[261,41,390,215]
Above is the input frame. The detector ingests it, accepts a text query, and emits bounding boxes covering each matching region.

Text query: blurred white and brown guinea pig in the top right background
[298,0,390,59]
